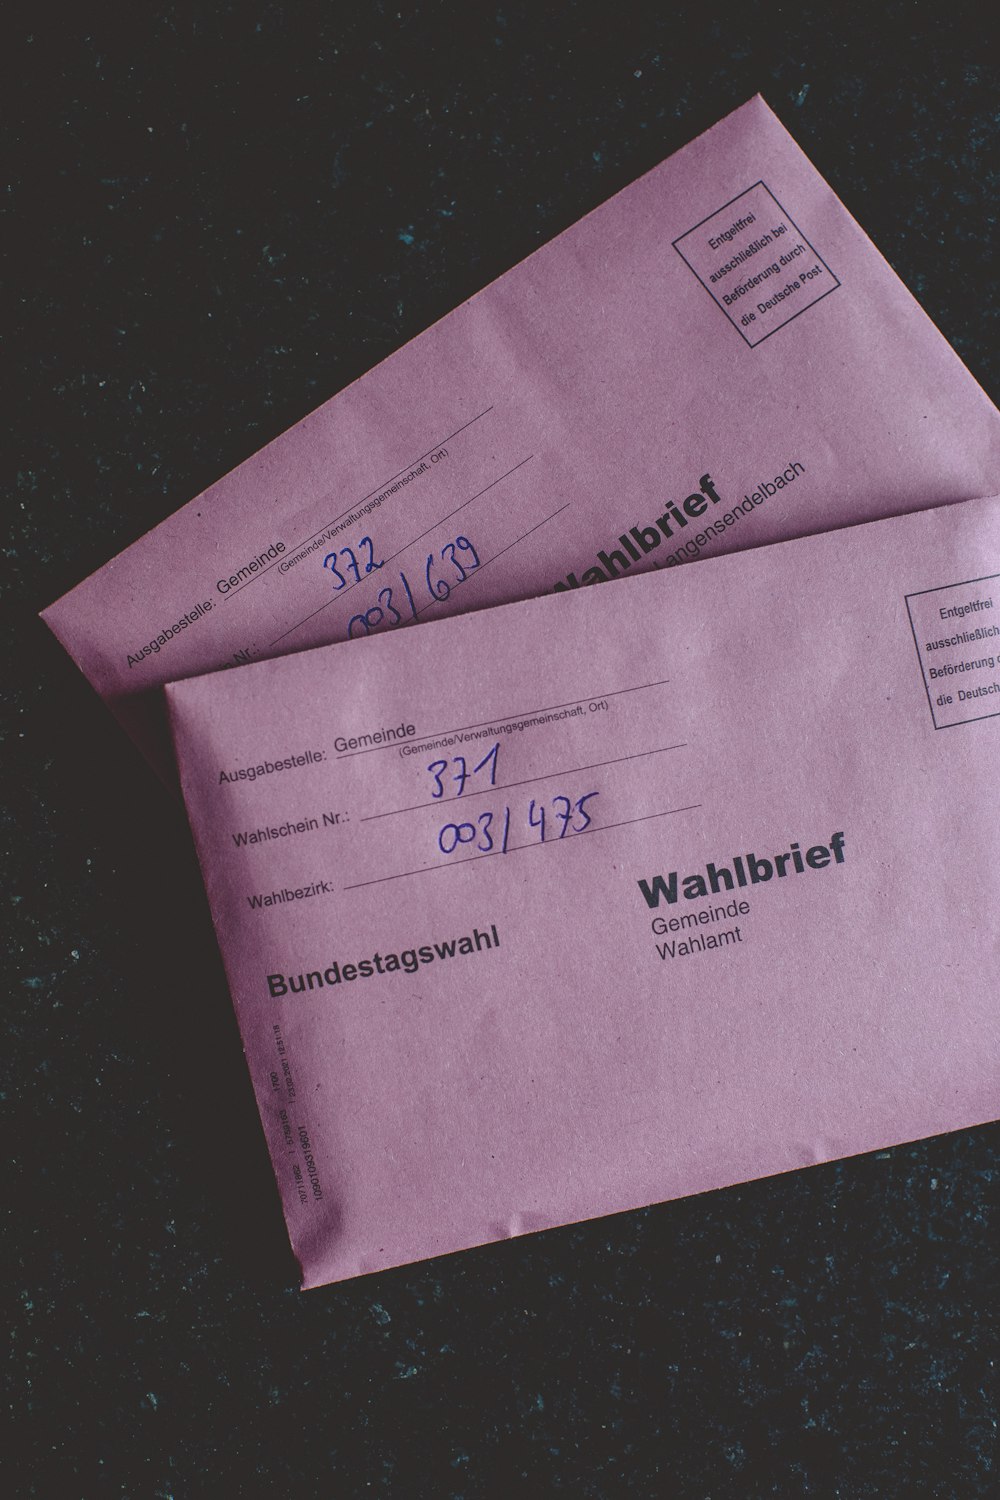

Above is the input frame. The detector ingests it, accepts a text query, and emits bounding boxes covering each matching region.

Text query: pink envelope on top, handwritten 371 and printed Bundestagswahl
[166,500,1000,1287]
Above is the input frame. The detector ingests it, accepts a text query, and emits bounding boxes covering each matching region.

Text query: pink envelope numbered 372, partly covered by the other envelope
[45,99,1000,777]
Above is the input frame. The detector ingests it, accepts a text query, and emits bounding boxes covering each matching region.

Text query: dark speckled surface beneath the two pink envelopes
[0,0,1000,1500]
